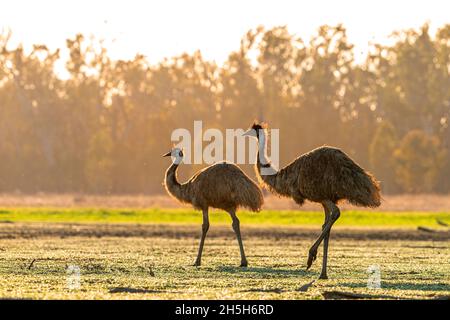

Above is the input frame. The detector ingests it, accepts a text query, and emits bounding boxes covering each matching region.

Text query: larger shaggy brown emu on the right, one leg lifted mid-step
[244,123,380,279]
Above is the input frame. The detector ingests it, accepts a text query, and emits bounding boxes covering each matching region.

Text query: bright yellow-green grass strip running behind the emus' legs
[0,208,450,228]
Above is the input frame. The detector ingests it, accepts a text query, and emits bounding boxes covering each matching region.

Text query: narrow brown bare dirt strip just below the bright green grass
[0,223,450,241]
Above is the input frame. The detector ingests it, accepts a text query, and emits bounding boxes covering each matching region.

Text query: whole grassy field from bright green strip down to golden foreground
[0,208,450,299]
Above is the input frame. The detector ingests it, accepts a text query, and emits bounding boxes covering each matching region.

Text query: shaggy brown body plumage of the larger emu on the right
[257,146,380,208]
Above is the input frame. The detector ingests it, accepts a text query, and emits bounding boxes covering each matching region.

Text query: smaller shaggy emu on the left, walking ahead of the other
[164,148,264,267]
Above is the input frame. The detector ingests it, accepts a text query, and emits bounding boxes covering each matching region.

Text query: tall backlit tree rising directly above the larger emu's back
[299,25,354,149]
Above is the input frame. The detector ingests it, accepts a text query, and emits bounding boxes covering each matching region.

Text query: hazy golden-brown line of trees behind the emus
[0,24,450,194]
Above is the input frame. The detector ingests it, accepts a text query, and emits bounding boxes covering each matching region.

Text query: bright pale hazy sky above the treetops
[0,0,450,63]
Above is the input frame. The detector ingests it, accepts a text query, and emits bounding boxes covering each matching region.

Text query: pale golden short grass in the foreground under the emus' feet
[0,232,450,299]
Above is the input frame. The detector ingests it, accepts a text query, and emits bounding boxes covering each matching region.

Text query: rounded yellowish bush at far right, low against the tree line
[395,130,447,193]
